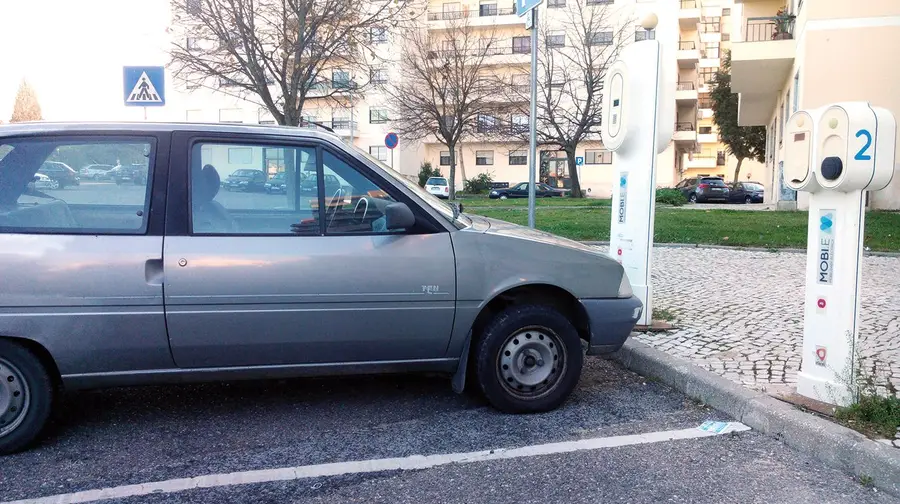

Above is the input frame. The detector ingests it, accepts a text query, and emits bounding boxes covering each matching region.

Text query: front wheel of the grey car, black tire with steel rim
[475,305,584,413]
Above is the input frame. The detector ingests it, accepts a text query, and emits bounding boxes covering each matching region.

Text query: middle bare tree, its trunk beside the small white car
[385,16,502,199]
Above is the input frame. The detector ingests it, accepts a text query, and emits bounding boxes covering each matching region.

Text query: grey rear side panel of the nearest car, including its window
[0,134,173,379]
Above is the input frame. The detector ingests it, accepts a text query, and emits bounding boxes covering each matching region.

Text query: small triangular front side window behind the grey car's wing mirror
[321,150,403,234]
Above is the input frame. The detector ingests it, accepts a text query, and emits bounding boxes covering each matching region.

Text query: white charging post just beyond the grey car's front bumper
[600,14,675,326]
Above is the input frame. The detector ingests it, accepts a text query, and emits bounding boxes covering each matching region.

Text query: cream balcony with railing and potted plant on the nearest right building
[731,17,797,126]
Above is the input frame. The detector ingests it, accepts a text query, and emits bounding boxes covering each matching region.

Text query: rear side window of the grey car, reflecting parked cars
[0,136,155,234]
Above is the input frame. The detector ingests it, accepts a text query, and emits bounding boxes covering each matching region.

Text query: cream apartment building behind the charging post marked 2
[732,0,900,209]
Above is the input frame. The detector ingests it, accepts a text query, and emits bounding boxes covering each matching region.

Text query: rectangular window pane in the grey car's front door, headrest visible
[188,143,321,236]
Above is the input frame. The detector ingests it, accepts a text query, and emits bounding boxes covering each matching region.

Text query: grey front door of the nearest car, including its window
[164,134,456,368]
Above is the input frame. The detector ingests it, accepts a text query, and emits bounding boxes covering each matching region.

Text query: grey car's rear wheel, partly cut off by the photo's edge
[0,340,54,455]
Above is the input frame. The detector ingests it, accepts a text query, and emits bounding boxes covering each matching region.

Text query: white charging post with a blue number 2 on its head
[784,102,897,406]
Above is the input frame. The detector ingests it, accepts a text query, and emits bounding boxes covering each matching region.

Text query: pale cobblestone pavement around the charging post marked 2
[624,247,900,393]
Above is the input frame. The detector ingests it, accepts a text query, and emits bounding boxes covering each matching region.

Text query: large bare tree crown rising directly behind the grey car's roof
[170,0,413,126]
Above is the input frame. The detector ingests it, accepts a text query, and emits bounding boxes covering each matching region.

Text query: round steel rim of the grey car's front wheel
[497,327,566,398]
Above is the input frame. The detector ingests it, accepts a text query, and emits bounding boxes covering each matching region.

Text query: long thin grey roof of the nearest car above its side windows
[0,121,343,143]
